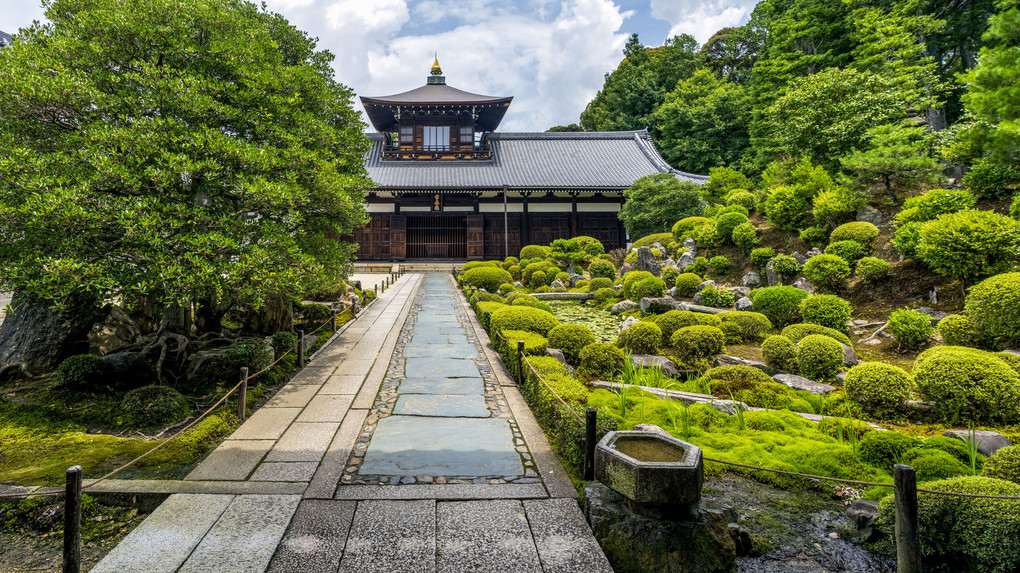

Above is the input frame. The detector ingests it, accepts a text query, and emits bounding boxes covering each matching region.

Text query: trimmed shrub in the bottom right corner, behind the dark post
[878,476,1020,573]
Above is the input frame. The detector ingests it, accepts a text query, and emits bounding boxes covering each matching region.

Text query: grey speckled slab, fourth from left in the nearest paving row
[339,500,436,573]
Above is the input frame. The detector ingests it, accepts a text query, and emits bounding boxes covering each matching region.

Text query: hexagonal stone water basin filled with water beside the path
[595,431,705,509]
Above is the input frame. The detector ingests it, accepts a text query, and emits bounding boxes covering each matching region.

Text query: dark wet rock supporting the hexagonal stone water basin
[583,481,737,573]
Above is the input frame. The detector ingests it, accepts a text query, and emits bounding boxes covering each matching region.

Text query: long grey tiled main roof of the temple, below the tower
[365,131,708,189]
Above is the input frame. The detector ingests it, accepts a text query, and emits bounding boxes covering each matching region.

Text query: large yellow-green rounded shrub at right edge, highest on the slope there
[917,211,1020,282]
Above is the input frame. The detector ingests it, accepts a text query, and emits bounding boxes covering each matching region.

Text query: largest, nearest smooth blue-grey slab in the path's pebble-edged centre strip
[358,416,524,476]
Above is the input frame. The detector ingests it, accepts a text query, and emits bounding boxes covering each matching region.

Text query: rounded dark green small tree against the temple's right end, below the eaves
[619,173,705,237]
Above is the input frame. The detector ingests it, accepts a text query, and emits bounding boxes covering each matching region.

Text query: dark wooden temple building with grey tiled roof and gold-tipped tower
[354,60,707,261]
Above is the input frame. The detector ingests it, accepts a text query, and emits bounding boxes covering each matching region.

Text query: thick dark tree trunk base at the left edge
[0,293,104,371]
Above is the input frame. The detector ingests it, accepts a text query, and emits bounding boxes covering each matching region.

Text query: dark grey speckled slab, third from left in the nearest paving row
[266,500,357,573]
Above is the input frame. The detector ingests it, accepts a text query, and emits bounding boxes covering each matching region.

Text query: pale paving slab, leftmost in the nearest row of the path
[92,493,235,573]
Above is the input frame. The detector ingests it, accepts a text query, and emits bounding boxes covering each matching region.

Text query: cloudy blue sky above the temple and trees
[0,0,756,132]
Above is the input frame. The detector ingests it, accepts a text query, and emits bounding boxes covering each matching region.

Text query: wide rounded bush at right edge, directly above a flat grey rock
[913,347,1020,424]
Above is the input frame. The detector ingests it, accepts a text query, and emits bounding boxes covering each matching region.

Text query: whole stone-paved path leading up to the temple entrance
[93,274,612,573]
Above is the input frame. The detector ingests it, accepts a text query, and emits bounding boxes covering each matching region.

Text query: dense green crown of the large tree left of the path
[0,0,371,306]
